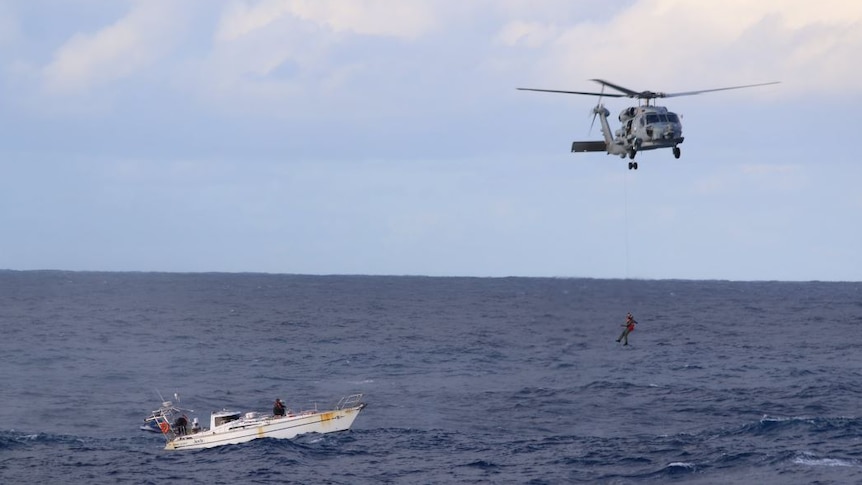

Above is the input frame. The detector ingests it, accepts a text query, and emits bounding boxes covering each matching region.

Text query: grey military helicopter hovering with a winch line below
[517,79,780,170]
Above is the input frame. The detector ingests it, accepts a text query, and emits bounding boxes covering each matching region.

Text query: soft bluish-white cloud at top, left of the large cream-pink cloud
[192,0,452,119]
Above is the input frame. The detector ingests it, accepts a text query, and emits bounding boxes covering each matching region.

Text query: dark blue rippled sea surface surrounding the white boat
[0,272,862,484]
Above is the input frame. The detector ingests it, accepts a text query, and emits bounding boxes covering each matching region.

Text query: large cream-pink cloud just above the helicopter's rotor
[499,0,862,94]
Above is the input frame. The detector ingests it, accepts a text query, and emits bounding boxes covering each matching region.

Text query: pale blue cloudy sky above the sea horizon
[0,0,862,281]
